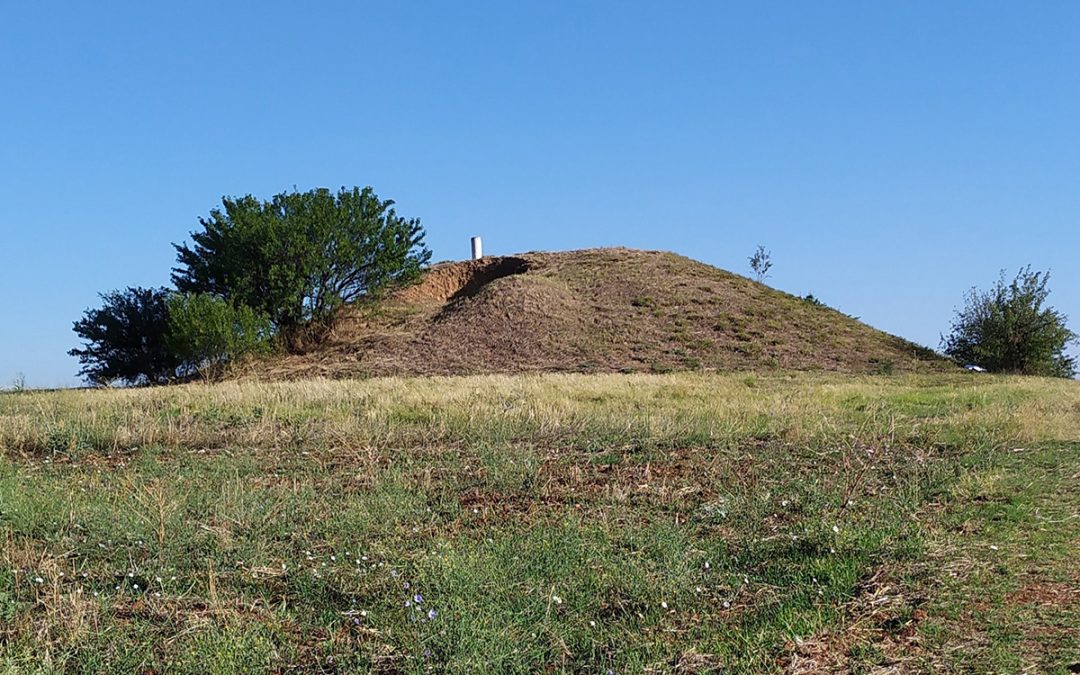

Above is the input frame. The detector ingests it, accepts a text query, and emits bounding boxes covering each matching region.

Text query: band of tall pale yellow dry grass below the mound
[0,374,1080,456]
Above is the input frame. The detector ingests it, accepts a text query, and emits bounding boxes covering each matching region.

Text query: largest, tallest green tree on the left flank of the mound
[173,188,431,338]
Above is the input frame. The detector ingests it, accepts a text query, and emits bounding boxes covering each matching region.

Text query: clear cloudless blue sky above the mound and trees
[0,0,1080,387]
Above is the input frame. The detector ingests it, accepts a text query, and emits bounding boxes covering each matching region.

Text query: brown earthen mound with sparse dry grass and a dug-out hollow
[269,248,946,378]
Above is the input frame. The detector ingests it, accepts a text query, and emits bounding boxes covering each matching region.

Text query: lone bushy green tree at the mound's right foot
[942,267,1077,377]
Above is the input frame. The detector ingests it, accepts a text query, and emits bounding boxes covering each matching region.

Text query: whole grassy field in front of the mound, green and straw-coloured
[0,374,1080,673]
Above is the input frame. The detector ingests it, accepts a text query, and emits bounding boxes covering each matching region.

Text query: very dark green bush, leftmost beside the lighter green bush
[68,287,180,384]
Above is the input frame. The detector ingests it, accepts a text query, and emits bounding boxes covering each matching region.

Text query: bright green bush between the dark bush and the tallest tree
[166,293,272,375]
